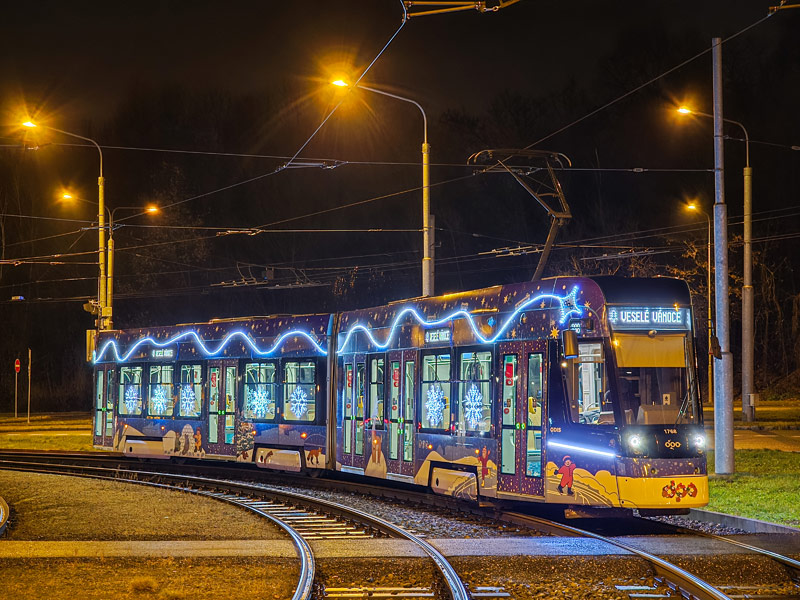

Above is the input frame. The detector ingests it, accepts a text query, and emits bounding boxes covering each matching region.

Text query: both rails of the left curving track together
[0,453,470,600]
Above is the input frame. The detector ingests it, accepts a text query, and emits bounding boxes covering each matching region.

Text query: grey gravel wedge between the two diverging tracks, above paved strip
[247,485,543,539]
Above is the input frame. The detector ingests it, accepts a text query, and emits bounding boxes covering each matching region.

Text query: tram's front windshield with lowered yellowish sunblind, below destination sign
[612,332,699,425]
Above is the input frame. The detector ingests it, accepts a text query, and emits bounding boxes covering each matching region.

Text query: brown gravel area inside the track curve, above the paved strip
[0,471,286,540]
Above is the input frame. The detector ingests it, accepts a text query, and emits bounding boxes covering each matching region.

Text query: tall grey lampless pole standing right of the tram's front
[711,38,734,474]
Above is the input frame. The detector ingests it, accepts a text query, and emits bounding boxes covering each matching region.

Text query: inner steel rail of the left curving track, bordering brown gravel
[0,459,316,600]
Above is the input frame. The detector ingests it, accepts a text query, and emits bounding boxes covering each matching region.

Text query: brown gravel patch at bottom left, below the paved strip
[0,558,299,600]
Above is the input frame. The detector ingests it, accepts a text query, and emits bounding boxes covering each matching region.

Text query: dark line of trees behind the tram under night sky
[0,14,800,411]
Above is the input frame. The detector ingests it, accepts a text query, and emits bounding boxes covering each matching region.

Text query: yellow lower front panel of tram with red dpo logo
[617,475,708,508]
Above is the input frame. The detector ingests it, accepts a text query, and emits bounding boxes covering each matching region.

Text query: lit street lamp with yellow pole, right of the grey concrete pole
[678,106,755,421]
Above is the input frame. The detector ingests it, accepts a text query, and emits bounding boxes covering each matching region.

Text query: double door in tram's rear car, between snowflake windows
[208,360,238,454]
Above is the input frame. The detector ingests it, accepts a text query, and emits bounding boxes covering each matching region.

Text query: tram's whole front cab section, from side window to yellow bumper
[546,277,708,514]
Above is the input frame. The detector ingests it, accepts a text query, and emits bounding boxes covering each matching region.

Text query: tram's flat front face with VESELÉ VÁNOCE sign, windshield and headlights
[606,303,708,511]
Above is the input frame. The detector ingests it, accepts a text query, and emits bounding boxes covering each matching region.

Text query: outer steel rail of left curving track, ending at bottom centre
[0,453,470,600]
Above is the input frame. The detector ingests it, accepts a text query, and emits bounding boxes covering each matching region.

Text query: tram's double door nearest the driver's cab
[497,340,547,496]
